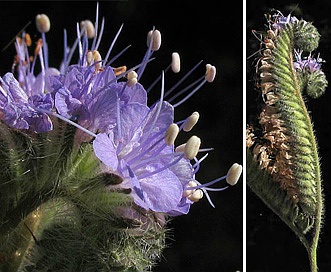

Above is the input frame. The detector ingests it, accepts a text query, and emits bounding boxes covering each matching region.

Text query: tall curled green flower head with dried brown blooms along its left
[246,13,327,233]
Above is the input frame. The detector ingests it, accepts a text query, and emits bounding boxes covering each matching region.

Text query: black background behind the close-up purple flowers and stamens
[0,1,243,272]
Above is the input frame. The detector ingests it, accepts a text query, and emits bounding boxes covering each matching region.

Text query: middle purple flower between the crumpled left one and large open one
[50,65,147,132]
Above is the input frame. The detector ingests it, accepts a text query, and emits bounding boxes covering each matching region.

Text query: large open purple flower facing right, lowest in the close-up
[93,98,194,213]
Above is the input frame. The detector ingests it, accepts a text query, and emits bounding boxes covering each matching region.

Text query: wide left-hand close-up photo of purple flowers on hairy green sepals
[0,1,244,272]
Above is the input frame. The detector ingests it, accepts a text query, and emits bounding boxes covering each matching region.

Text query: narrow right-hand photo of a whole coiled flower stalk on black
[246,0,331,272]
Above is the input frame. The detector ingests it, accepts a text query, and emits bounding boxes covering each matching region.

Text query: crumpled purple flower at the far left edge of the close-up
[0,73,53,133]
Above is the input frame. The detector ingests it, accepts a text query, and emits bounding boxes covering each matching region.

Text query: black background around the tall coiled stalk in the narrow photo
[246,0,331,272]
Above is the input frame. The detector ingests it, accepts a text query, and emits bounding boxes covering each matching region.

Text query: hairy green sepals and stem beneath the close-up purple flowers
[0,119,166,272]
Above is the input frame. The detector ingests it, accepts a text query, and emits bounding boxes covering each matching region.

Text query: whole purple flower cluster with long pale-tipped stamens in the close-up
[0,6,242,216]
